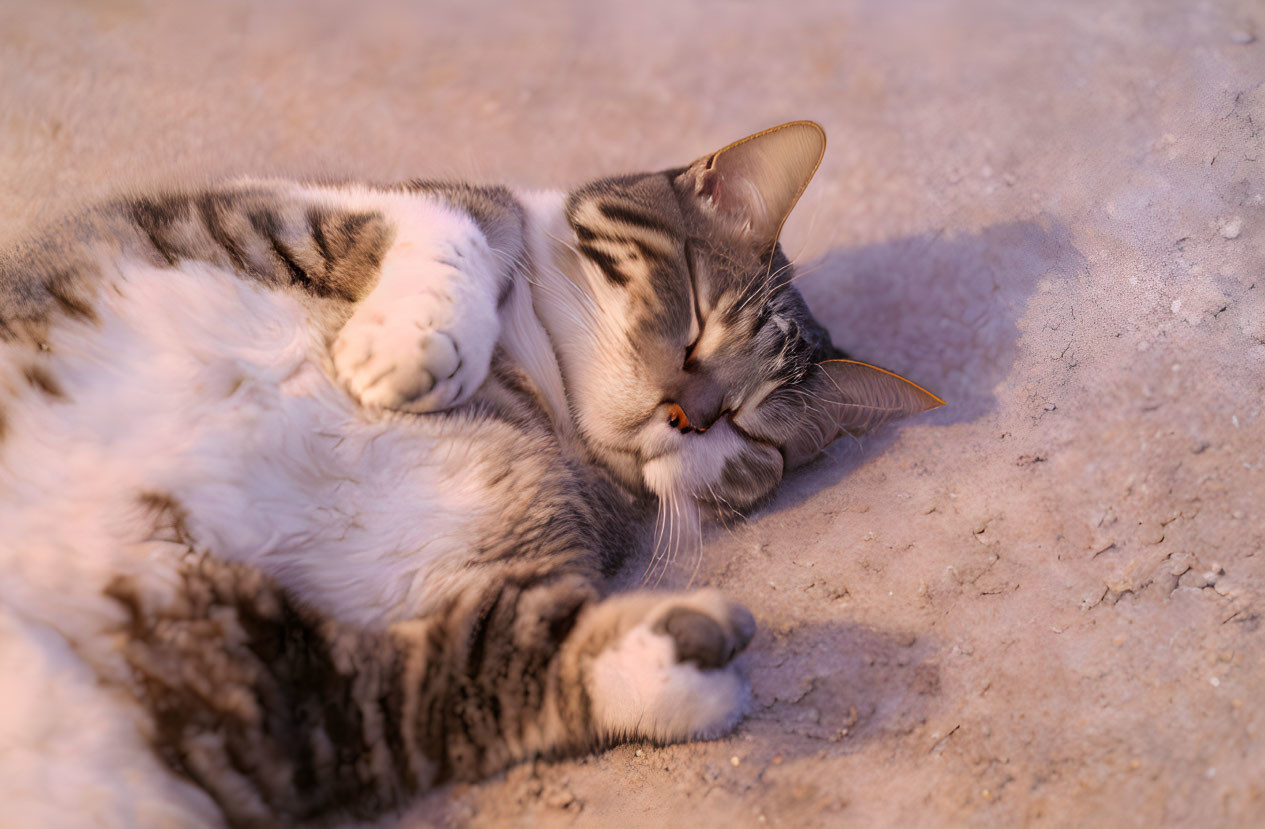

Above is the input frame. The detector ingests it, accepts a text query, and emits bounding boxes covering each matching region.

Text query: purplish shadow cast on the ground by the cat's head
[756,219,1087,508]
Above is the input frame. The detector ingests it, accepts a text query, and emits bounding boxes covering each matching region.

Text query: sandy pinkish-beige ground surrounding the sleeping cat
[0,0,1265,828]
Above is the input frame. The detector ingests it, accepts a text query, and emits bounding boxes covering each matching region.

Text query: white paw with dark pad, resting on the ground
[589,590,755,742]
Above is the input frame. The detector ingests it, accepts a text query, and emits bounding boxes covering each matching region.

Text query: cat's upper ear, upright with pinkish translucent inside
[683,122,826,246]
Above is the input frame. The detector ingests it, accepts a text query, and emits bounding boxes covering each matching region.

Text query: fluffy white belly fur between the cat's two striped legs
[0,255,508,628]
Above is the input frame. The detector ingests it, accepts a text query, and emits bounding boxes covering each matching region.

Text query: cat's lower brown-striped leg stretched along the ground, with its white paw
[110,558,755,825]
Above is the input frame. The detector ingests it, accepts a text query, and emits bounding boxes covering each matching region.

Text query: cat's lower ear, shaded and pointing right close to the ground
[782,359,945,468]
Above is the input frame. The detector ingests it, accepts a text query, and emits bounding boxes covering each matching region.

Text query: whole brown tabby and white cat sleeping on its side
[0,122,939,826]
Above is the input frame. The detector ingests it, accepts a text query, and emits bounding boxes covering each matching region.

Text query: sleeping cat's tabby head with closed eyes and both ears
[538,122,940,511]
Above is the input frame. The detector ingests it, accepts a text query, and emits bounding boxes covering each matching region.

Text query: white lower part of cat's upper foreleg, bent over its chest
[331,191,521,413]
